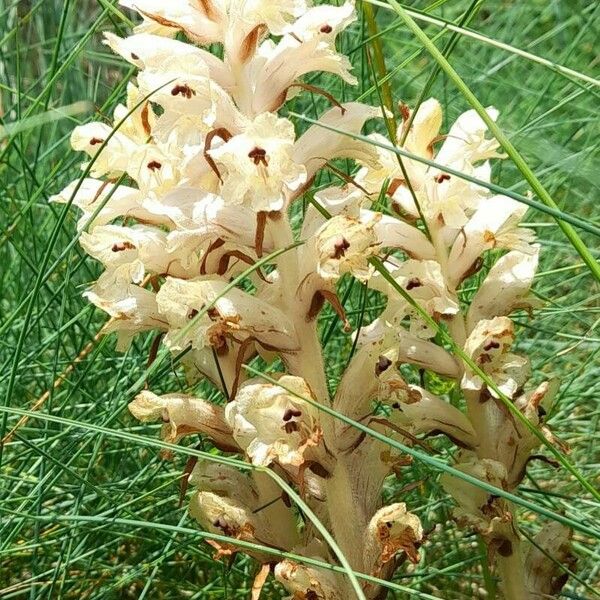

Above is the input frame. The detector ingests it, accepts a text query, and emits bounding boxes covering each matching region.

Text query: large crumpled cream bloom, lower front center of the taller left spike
[225,375,322,467]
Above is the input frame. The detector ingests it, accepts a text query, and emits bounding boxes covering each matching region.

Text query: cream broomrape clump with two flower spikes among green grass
[53,0,575,600]
